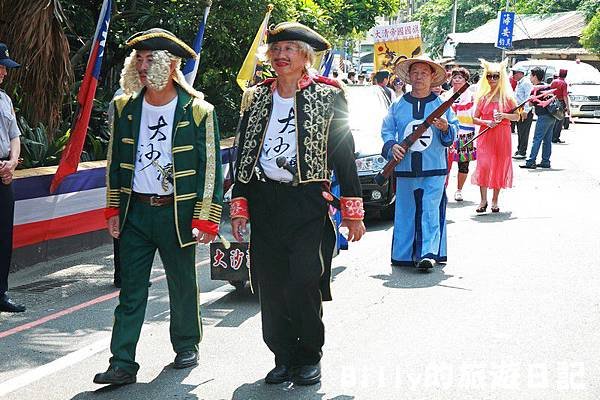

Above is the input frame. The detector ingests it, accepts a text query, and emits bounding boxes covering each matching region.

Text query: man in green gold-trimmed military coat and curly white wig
[94,29,223,385]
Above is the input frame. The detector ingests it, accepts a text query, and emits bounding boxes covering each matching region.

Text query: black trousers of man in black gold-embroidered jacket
[248,182,331,365]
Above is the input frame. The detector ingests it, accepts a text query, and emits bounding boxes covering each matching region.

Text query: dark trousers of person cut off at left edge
[0,182,15,296]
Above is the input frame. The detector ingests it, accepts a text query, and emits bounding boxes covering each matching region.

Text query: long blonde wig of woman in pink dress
[475,58,517,112]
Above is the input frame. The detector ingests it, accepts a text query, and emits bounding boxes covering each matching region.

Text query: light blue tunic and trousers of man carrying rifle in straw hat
[381,93,458,265]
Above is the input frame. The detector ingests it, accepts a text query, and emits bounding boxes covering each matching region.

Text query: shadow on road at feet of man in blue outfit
[371,264,453,289]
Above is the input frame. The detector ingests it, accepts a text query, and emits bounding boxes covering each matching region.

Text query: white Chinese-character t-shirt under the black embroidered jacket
[259,91,297,182]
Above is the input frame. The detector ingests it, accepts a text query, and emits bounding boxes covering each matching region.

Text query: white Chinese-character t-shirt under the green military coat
[133,97,177,196]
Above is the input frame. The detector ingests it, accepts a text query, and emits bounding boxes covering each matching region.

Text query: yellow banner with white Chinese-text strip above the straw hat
[373,21,423,71]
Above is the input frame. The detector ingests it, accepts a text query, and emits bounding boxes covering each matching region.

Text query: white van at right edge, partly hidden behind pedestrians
[514,60,600,118]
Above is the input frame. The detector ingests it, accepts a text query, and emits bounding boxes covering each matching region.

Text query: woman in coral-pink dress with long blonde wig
[471,59,519,213]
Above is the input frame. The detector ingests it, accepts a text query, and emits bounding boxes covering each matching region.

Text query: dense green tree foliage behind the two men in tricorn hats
[0,0,402,152]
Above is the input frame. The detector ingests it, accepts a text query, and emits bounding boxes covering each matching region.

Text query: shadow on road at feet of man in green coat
[71,366,203,400]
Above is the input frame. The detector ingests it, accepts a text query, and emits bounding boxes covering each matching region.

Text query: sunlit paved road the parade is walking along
[0,117,600,400]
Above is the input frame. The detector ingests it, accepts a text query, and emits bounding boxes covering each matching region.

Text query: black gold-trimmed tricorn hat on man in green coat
[125,28,198,59]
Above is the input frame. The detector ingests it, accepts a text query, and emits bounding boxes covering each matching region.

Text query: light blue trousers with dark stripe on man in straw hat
[392,175,447,266]
